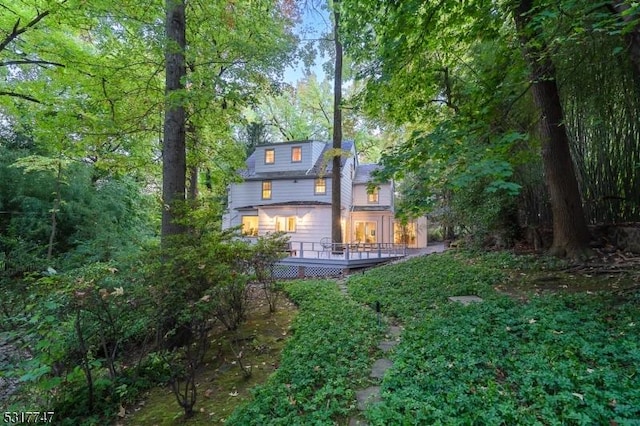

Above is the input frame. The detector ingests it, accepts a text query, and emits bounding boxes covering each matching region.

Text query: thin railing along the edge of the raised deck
[288,241,407,260]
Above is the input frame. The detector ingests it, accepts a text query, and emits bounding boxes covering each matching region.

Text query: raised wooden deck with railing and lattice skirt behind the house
[274,241,407,278]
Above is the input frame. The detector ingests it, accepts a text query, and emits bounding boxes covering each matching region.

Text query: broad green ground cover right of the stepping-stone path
[349,253,640,425]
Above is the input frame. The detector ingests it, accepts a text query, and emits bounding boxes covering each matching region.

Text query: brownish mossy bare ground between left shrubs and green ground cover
[119,299,297,426]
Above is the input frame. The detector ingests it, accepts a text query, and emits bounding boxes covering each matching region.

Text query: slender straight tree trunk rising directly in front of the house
[331,0,342,243]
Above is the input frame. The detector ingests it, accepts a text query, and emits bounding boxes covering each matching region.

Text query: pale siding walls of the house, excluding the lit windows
[223,141,427,247]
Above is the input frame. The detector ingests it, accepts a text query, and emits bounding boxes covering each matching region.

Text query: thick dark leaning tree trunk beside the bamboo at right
[514,0,590,258]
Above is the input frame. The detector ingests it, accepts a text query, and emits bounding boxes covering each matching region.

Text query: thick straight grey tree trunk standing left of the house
[162,0,187,243]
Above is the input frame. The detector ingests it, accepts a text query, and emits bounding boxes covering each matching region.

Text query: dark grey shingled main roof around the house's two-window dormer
[239,140,354,180]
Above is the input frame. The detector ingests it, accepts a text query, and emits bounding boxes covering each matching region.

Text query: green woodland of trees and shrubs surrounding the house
[0,0,640,424]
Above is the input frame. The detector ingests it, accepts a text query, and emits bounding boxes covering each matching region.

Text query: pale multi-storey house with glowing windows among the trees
[223,141,427,247]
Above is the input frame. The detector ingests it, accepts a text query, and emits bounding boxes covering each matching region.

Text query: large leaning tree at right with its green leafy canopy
[343,0,635,257]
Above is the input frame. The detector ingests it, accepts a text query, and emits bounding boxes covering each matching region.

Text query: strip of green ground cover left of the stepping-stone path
[227,280,381,425]
